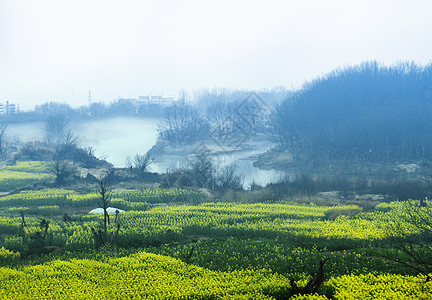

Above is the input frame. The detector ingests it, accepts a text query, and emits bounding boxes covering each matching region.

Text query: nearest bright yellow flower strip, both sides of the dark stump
[0,252,432,299]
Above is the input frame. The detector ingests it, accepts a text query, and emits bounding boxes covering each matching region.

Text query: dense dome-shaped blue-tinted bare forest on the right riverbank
[273,61,432,162]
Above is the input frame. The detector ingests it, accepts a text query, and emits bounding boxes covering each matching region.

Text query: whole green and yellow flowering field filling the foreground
[0,166,432,299]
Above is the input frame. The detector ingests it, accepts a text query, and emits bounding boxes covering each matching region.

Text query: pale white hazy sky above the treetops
[0,0,432,109]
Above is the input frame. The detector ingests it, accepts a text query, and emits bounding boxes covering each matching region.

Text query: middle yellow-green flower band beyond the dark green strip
[0,202,402,250]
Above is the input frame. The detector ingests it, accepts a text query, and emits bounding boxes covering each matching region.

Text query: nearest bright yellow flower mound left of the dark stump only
[0,253,294,299]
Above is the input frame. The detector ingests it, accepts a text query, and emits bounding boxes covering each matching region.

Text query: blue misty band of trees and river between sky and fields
[2,61,432,193]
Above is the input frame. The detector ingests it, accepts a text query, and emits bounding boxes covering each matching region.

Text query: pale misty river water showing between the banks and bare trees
[8,117,283,188]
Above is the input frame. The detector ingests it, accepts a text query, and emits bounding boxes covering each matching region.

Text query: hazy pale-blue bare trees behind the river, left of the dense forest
[158,87,290,145]
